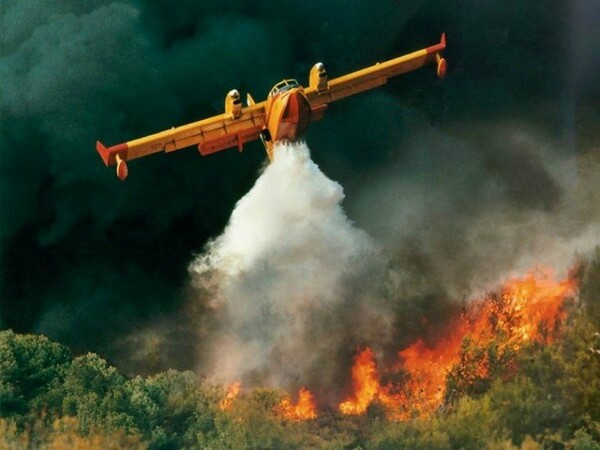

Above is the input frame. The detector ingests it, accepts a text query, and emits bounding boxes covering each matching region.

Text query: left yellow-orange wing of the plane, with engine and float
[96,100,266,180]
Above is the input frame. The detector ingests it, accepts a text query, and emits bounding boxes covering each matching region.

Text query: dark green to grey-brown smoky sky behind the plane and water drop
[0,0,600,380]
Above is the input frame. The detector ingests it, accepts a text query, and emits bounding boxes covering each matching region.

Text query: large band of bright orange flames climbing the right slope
[339,269,576,420]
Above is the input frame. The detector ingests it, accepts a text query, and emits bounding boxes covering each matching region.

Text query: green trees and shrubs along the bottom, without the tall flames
[0,250,600,450]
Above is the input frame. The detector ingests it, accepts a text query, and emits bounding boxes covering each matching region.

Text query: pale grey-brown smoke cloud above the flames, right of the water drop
[351,120,600,299]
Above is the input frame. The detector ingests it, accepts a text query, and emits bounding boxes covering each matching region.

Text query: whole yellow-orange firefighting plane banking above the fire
[96,34,447,180]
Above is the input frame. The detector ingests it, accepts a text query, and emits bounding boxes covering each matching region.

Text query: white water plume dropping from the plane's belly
[190,143,387,387]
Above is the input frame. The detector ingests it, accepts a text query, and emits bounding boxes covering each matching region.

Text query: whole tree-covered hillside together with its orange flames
[0,254,600,449]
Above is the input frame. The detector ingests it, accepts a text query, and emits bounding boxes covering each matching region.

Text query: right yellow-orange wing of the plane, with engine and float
[305,34,447,121]
